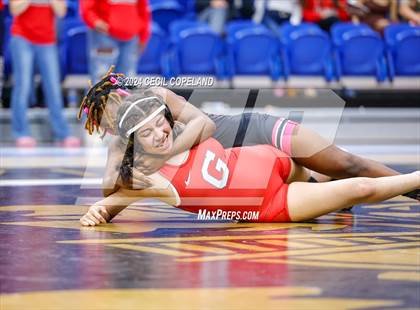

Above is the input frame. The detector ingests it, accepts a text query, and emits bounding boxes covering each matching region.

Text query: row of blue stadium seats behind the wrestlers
[5,1,420,82]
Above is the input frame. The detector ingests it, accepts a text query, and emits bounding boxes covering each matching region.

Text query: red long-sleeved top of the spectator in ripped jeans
[80,0,151,44]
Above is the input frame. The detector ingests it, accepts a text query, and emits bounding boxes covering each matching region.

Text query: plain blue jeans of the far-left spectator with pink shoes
[10,36,69,140]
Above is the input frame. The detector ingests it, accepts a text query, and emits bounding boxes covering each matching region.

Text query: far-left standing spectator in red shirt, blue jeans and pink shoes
[9,0,80,147]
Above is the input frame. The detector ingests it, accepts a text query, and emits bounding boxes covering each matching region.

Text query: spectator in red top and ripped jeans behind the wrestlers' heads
[80,0,151,81]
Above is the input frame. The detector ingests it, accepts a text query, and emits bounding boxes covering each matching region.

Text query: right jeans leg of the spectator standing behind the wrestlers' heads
[116,36,140,76]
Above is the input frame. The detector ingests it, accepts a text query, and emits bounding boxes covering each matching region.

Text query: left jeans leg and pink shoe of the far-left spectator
[10,36,36,147]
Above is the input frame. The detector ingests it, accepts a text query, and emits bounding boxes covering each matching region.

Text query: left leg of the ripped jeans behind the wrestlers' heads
[87,30,120,83]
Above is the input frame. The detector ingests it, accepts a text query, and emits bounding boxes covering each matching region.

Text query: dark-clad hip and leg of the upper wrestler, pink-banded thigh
[209,113,399,179]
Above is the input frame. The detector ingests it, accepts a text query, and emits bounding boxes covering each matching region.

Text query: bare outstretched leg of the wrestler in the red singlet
[287,171,420,221]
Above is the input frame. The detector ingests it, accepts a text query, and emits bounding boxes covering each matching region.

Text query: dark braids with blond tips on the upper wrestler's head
[77,66,133,137]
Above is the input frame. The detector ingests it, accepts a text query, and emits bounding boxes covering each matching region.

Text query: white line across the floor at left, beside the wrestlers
[0,178,102,186]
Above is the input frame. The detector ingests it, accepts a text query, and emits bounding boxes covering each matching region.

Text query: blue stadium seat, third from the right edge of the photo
[280,23,334,82]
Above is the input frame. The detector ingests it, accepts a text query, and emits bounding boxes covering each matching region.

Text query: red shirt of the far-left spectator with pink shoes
[11,0,56,44]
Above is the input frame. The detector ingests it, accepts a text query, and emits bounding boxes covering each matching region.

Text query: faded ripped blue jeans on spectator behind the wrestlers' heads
[87,30,140,83]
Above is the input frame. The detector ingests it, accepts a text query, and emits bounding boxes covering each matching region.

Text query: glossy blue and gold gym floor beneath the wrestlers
[0,146,420,310]
